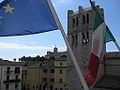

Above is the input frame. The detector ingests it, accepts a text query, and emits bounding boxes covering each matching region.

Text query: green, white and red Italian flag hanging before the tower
[85,0,115,87]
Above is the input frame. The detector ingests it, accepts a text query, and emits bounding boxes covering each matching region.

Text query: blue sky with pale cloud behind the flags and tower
[0,0,120,61]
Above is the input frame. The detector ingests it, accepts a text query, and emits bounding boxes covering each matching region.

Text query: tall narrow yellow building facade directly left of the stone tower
[54,57,67,90]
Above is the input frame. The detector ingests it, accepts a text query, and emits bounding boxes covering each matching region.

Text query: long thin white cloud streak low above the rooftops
[0,42,65,50]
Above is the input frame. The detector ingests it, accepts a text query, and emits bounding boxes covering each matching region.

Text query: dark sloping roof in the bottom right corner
[95,75,120,90]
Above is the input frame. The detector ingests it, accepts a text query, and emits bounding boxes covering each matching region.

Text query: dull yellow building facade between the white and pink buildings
[22,66,42,90]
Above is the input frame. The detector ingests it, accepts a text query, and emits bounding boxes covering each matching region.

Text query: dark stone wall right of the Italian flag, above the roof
[105,52,120,76]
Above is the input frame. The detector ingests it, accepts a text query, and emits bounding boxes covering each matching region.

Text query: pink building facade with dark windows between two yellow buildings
[41,60,54,90]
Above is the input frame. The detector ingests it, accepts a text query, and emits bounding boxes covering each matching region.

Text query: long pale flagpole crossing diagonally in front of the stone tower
[48,0,89,90]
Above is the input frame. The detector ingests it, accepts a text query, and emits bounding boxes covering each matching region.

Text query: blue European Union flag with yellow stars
[0,0,58,36]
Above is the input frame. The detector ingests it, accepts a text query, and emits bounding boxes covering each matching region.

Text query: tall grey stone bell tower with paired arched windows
[67,6,103,90]
